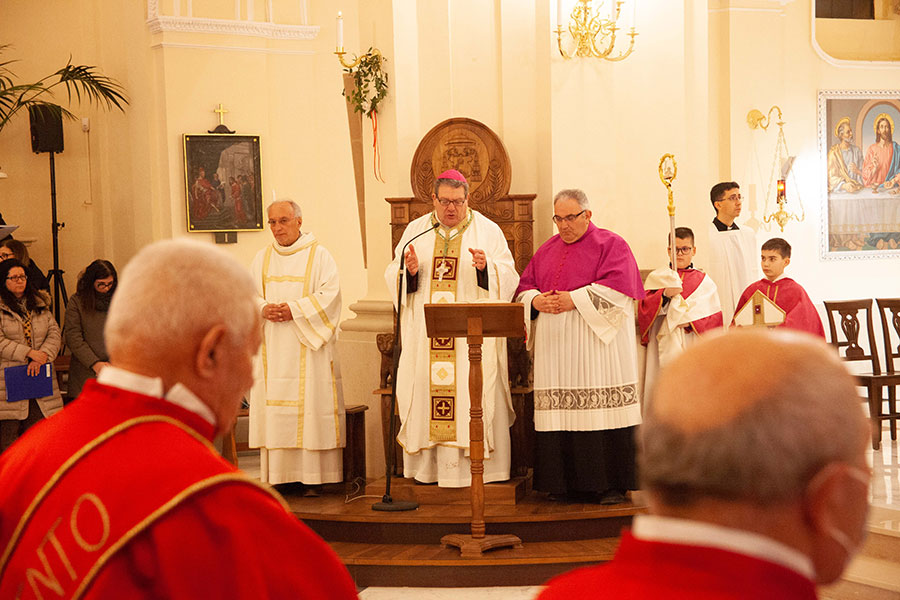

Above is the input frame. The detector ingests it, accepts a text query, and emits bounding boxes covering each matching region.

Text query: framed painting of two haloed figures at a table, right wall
[818,90,900,259]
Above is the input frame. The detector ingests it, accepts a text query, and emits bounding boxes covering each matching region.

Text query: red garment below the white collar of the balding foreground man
[538,531,816,600]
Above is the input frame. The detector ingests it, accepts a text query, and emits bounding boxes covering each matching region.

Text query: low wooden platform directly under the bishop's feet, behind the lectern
[366,477,531,506]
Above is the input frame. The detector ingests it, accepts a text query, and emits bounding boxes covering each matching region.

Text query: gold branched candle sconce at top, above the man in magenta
[556,0,637,61]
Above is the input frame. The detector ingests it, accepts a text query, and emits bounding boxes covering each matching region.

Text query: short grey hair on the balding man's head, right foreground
[638,334,864,506]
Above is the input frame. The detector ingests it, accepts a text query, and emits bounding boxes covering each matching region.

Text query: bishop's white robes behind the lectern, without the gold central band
[385,209,519,487]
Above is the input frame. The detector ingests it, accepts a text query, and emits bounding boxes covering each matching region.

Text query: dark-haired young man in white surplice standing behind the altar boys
[706,181,759,326]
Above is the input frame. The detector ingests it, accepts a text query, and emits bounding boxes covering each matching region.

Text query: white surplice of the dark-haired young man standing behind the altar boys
[706,223,759,328]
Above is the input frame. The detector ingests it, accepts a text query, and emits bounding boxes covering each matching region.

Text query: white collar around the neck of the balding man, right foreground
[631,515,815,579]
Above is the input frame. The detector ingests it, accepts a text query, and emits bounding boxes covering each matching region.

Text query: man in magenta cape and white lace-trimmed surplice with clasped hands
[516,189,644,504]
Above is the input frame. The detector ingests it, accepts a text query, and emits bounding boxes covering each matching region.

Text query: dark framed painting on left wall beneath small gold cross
[184,134,265,232]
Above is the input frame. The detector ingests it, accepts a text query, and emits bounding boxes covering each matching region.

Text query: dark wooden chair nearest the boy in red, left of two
[825,299,892,450]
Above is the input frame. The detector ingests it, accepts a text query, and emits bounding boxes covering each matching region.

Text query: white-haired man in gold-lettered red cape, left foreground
[0,240,356,600]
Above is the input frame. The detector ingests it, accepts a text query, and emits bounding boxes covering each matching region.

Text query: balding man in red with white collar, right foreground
[540,332,870,600]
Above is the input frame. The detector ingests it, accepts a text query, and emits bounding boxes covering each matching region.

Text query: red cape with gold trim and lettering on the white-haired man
[0,381,356,600]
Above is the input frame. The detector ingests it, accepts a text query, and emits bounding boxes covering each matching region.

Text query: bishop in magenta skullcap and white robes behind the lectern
[385,170,519,487]
